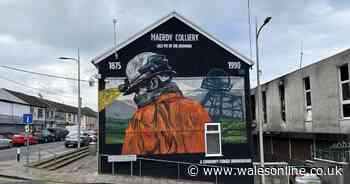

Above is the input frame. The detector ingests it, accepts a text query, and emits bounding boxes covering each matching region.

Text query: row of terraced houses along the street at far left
[0,89,97,133]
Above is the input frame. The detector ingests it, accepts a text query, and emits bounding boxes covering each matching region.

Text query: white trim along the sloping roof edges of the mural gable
[91,12,254,65]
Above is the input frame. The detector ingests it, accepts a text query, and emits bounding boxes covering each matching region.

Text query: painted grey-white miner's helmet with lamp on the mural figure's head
[119,52,176,95]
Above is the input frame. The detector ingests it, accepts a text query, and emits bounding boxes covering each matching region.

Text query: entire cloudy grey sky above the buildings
[0,0,350,109]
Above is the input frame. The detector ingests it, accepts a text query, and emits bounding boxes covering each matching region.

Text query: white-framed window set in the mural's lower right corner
[205,123,222,156]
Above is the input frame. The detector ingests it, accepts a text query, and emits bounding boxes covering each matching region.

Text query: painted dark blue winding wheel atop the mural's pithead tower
[201,68,233,91]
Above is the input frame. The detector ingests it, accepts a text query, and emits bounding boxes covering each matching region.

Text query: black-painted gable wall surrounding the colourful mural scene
[97,17,253,183]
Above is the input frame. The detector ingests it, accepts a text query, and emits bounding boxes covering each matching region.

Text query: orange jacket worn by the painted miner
[122,92,210,155]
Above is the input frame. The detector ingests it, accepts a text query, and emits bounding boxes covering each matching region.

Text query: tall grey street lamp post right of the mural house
[255,17,271,184]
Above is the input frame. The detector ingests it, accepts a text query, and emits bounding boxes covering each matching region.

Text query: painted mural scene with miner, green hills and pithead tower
[105,52,247,155]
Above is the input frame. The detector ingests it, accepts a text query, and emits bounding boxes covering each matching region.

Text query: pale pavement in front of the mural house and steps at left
[0,145,211,184]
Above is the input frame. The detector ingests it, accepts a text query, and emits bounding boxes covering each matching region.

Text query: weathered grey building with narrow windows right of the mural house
[250,50,350,161]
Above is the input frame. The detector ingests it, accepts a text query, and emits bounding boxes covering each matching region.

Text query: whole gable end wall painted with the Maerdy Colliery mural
[93,13,253,183]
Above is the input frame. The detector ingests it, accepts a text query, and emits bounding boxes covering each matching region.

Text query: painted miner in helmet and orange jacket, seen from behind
[119,52,210,155]
